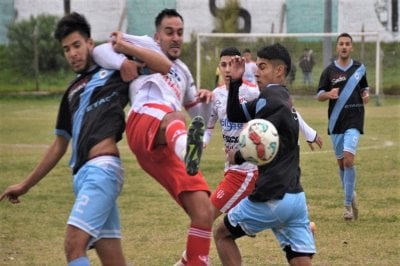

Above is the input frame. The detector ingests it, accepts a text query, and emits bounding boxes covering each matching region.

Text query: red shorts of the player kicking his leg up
[126,105,210,205]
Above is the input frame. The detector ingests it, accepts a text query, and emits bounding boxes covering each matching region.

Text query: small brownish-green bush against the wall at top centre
[215,0,240,33]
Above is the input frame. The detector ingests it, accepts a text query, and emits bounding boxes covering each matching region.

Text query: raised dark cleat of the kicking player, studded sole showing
[185,116,204,175]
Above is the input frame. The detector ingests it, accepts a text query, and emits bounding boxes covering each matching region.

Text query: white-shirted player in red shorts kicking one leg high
[92,9,213,265]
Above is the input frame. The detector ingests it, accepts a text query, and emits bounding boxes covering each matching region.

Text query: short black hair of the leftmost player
[54,12,91,42]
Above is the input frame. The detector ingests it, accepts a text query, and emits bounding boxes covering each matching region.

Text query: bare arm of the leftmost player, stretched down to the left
[0,136,68,203]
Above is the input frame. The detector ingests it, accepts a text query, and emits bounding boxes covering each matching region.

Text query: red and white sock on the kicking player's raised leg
[165,120,187,158]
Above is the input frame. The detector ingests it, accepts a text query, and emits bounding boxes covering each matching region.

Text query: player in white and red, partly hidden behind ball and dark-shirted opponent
[204,47,322,220]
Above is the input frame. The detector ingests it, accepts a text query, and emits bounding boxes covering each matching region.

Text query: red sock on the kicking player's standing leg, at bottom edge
[186,225,211,266]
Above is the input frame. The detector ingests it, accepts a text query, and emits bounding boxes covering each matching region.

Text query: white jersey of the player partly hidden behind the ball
[204,80,260,172]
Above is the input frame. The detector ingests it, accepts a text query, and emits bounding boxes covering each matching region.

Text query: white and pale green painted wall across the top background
[0,0,400,43]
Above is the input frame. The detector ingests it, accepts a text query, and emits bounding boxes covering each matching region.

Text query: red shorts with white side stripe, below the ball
[211,170,258,213]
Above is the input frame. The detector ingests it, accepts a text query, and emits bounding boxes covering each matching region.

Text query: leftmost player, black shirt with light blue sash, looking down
[0,13,143,266]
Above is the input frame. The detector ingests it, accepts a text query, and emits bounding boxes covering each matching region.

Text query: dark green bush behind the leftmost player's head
[8,15,66,76]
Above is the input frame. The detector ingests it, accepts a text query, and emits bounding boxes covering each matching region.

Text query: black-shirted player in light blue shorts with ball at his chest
[214,44,315,265]
